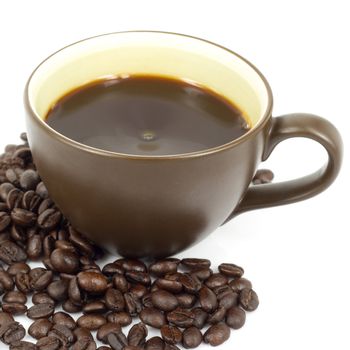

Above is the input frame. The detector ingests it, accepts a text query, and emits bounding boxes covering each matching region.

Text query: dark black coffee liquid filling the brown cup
[46,75,249,155]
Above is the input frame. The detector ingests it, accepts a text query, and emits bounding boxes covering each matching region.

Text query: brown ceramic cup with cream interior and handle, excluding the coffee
[25,31,342,257]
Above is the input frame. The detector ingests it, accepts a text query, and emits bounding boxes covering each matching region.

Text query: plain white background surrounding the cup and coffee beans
[0,0,350,350]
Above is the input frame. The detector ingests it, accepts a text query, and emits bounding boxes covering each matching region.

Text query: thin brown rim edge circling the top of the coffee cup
[24,30,273,160]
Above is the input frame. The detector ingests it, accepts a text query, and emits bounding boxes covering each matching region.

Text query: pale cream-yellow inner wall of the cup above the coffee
[28,32,268,126]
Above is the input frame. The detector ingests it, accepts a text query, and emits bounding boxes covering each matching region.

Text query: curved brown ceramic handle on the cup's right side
[225,113,343,223]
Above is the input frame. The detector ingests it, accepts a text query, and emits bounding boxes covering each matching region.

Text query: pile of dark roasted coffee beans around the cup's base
[0,134,268,350]
